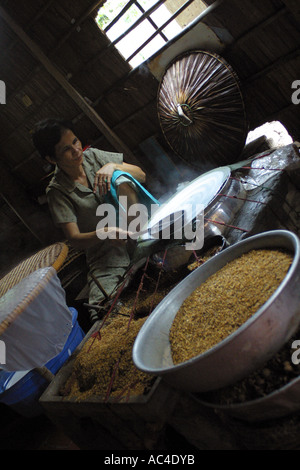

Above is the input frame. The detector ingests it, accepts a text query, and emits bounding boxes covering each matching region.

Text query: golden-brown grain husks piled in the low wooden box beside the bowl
[61,317,153,400]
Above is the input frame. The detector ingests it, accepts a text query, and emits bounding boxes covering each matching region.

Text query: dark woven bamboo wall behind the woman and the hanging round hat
[0,0,300,274]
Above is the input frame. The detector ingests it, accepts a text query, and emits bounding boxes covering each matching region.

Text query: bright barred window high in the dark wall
[96,0,206,67]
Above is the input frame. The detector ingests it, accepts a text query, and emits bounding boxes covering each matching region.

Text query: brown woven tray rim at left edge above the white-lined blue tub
[0,242,68,297]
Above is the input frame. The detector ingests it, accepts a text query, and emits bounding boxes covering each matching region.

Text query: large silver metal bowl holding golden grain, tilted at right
[133,230,300,392]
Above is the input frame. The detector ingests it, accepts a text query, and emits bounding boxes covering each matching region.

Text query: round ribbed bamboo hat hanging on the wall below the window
[158,51,248,170]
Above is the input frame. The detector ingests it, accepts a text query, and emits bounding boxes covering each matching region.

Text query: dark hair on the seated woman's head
[32,118,74,160]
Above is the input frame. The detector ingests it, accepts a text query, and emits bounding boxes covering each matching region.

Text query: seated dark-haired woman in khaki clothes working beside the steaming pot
[33,119,157,321]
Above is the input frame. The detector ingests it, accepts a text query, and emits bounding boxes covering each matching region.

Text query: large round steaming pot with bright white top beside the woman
[132,166,245,269]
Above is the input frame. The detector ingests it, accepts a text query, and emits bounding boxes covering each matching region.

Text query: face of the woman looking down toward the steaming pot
[55,129,83,169]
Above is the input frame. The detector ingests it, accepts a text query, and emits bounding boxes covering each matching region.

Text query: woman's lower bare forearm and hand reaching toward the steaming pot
[59,222,128,250]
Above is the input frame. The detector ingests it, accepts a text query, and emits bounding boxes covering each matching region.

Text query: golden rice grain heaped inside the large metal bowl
[170,249,293,364]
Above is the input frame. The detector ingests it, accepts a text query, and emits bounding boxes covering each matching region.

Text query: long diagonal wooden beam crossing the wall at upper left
[0,6,139,164]
